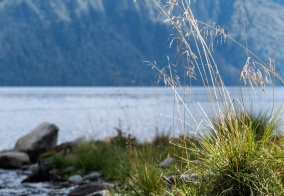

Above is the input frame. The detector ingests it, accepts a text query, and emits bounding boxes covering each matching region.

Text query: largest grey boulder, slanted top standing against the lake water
[15,123,58,163]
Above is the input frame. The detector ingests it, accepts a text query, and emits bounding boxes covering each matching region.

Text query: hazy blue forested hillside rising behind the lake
[0,0,284,86]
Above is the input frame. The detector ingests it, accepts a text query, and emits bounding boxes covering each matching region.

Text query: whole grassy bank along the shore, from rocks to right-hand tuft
[45,107,284,196]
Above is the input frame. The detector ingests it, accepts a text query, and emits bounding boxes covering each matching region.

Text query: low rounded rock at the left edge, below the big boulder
[0,151,30,169]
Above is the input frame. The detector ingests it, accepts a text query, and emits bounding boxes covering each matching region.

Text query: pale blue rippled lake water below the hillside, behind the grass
[0,87,284,150]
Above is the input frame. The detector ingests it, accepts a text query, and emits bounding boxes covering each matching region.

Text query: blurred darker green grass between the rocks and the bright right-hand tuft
[47,131,178,195]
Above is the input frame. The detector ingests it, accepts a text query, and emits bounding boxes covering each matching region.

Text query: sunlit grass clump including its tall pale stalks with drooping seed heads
[141,0,284,195]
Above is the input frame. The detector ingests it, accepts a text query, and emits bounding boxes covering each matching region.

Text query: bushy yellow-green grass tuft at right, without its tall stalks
[170,106,284,195]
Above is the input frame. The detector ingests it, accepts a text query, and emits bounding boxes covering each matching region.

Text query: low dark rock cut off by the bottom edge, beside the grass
[68,183,108,196]
